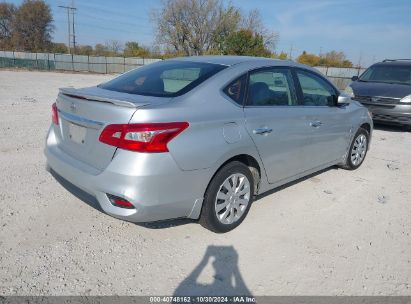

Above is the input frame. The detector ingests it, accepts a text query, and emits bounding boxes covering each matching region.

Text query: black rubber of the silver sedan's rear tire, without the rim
[200,161,254,233]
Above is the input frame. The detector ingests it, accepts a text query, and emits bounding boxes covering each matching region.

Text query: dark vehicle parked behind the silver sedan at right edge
[345,59,411,127]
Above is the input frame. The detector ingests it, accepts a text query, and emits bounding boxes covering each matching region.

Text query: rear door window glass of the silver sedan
[247,68,296,106]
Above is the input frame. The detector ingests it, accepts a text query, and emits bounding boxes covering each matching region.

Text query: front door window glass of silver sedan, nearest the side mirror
[297,71,336,106]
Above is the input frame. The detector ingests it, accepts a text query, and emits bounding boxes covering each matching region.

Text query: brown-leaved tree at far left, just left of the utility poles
[12,0,54,52]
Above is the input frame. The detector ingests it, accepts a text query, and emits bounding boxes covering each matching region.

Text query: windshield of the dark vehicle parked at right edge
[360,65,411,84]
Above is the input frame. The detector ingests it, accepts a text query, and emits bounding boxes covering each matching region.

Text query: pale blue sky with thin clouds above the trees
[5,0,411,65]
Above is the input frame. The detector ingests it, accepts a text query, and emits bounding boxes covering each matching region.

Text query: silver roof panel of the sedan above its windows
[171,55,299,66]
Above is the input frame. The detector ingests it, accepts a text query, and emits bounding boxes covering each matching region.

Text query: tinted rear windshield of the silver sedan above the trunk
[99,61,226,97]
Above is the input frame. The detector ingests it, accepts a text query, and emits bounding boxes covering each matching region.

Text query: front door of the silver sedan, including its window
[294,69,351,171]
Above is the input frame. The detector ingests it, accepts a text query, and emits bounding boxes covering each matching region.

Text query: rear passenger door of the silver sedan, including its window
[244,67,310,183]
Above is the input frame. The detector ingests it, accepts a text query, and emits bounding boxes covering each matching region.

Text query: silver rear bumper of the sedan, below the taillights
[45,128,211,222]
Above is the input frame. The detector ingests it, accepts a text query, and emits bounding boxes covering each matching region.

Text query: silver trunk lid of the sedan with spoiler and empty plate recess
[54,87,171,171]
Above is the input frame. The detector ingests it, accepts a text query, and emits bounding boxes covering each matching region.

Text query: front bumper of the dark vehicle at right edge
[363,103,411,125]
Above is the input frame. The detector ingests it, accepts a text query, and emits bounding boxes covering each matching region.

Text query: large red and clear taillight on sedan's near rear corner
[100,122,189,153]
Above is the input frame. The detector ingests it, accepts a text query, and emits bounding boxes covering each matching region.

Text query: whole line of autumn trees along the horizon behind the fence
[0,0,352,67]
